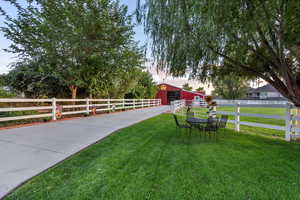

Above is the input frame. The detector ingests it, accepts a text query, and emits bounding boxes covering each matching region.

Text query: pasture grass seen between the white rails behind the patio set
[178,107,285,137]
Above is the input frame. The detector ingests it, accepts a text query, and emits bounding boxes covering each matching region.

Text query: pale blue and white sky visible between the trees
[0,0,212,94]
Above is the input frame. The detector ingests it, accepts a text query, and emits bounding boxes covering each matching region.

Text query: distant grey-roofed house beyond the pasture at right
[247,84,285,100]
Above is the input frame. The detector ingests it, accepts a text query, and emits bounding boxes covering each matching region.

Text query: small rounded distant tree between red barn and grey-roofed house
[212,74,249,99]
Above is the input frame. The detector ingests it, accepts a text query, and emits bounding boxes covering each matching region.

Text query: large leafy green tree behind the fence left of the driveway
[1,0,143,98]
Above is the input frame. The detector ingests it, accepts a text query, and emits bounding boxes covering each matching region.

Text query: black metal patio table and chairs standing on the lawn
[173,111,228,136]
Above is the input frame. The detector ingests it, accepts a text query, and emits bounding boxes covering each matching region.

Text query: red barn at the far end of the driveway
[156,83,205,105]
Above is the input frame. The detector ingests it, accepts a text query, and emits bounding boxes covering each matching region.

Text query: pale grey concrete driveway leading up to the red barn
[0,106,169,199]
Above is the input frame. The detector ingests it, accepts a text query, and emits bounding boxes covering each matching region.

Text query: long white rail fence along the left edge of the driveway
[0,98,161,122]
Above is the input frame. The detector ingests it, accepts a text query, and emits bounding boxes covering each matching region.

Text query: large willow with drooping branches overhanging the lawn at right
[138,0,300,106]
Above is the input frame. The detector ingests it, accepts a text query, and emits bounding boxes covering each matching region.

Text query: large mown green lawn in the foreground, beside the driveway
[6,114,300,200]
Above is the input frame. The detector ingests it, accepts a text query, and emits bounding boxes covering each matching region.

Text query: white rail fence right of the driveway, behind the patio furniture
[171,100,300,141]
